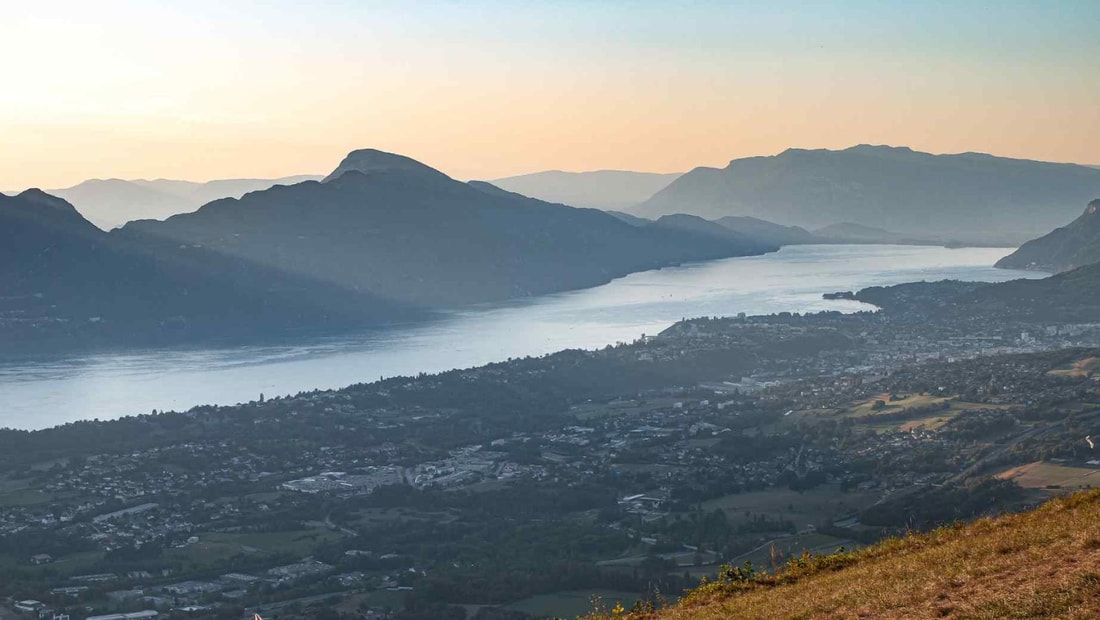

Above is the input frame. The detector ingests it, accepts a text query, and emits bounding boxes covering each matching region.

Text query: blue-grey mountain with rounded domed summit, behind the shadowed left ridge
[119,150,776,308]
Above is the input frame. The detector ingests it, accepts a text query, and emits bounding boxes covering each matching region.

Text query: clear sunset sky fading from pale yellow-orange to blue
[0,0,1100,189]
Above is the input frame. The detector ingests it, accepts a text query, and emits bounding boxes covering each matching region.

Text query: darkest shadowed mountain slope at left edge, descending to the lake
[0,189,415,355]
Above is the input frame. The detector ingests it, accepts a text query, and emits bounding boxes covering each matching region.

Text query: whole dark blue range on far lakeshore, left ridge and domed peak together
[0,150,778,354]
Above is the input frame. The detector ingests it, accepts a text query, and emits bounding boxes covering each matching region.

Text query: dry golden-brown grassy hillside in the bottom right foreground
[613,490,1100,620]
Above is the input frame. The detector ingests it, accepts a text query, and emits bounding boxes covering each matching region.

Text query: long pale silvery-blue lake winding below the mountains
[0,245,1041,429]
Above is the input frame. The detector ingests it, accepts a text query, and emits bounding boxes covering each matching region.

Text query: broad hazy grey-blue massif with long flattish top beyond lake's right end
[628,145,1100,244]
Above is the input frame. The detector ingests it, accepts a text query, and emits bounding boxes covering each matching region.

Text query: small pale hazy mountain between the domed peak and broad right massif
[492,170,681,214]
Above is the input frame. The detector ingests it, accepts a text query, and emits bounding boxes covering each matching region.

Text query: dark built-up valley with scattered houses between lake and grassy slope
[0,296,1100,620]
